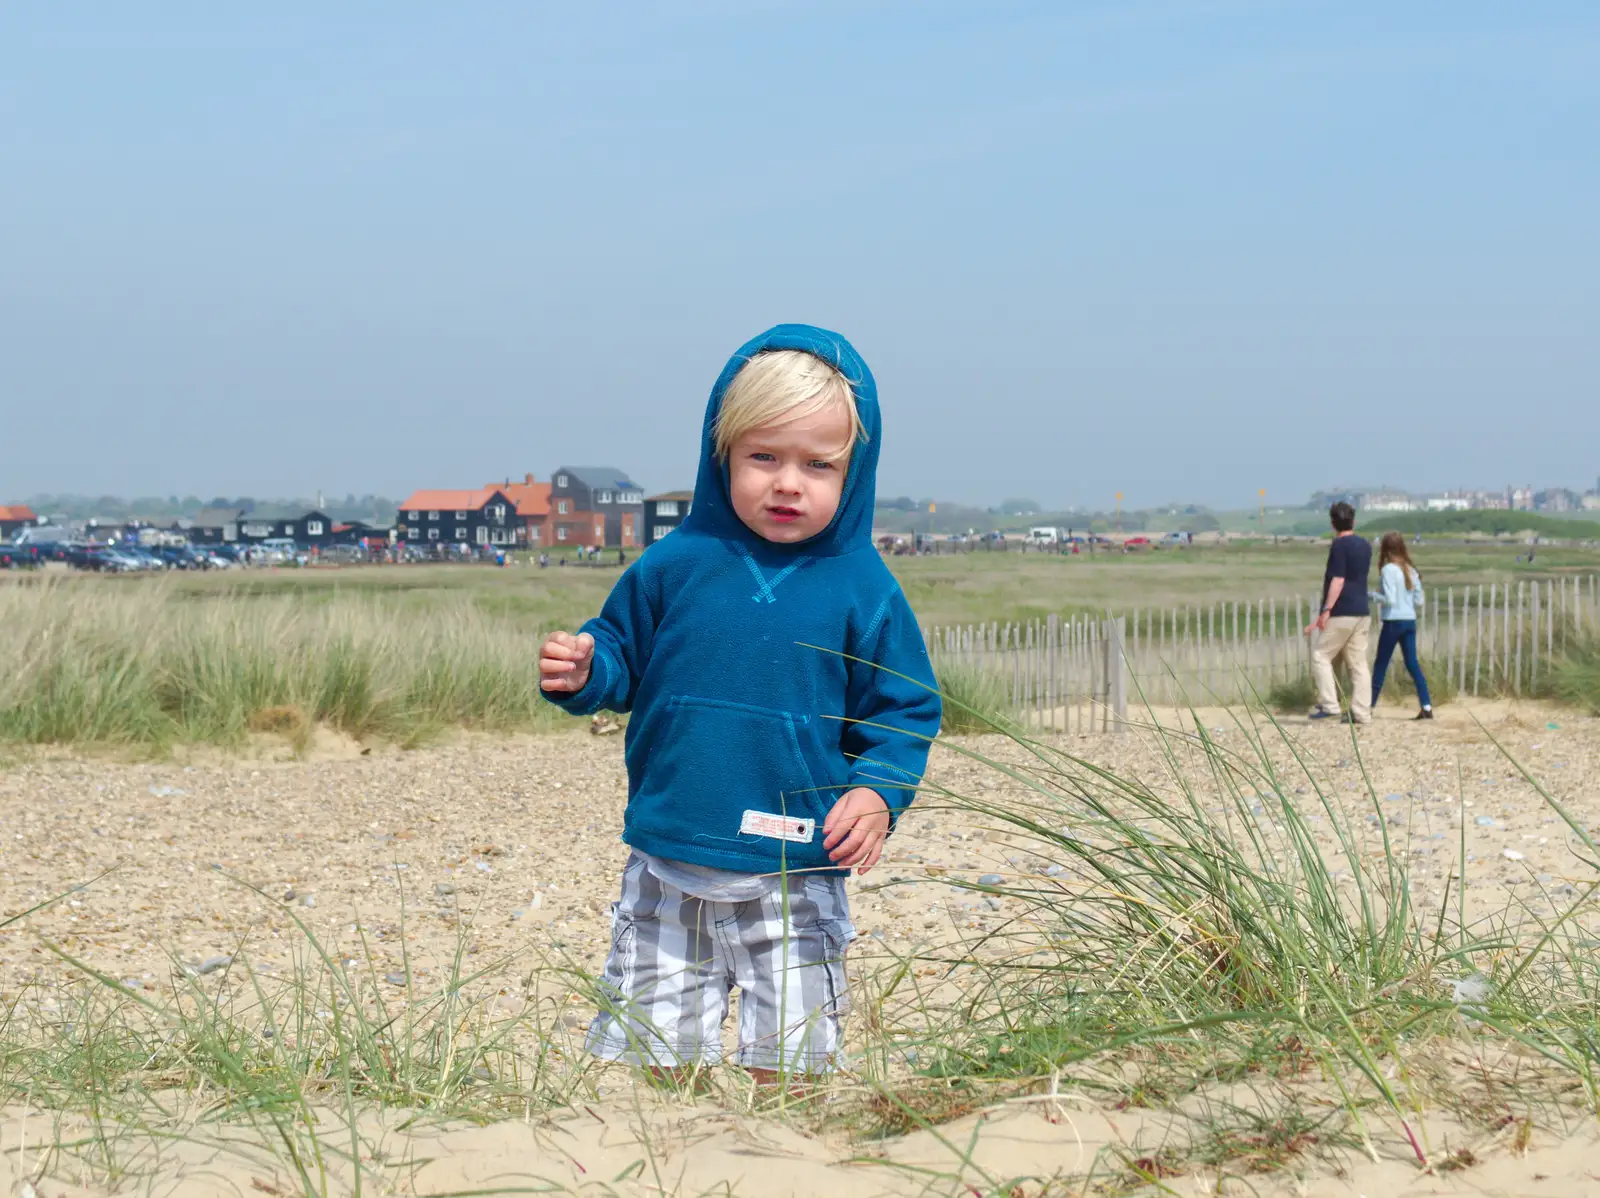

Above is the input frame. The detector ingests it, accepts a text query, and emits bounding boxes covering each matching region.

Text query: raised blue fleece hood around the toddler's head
[683,325,883,557]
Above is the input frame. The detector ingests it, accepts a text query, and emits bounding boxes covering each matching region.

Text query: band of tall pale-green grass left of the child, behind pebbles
[0,581,562,747]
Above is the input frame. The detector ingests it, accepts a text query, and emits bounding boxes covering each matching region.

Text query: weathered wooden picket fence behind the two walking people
[925,574,1600,733]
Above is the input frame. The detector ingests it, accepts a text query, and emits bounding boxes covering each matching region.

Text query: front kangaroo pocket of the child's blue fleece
[640,694,843,857]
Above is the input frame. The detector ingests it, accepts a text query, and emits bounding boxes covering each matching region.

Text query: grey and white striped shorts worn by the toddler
[587,853,856,1073]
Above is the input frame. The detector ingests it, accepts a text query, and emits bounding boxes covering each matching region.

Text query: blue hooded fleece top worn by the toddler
[546,325,939,873]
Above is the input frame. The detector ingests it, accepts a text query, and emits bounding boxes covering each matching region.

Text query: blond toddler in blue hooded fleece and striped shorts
[539,325,939,1081]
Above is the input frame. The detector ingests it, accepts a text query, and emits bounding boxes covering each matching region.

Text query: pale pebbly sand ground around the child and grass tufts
[0,704,1600,1198]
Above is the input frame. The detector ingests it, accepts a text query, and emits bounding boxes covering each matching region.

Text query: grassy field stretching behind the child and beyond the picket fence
[0,544,1600,747]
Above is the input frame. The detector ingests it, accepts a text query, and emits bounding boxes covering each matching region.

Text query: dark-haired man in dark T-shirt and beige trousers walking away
[1306,504,1373,725]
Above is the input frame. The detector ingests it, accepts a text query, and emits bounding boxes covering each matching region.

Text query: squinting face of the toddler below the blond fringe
[728,403,851,545]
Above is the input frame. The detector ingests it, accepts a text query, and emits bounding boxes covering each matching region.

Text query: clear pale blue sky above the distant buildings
[0,0,1600,507]
